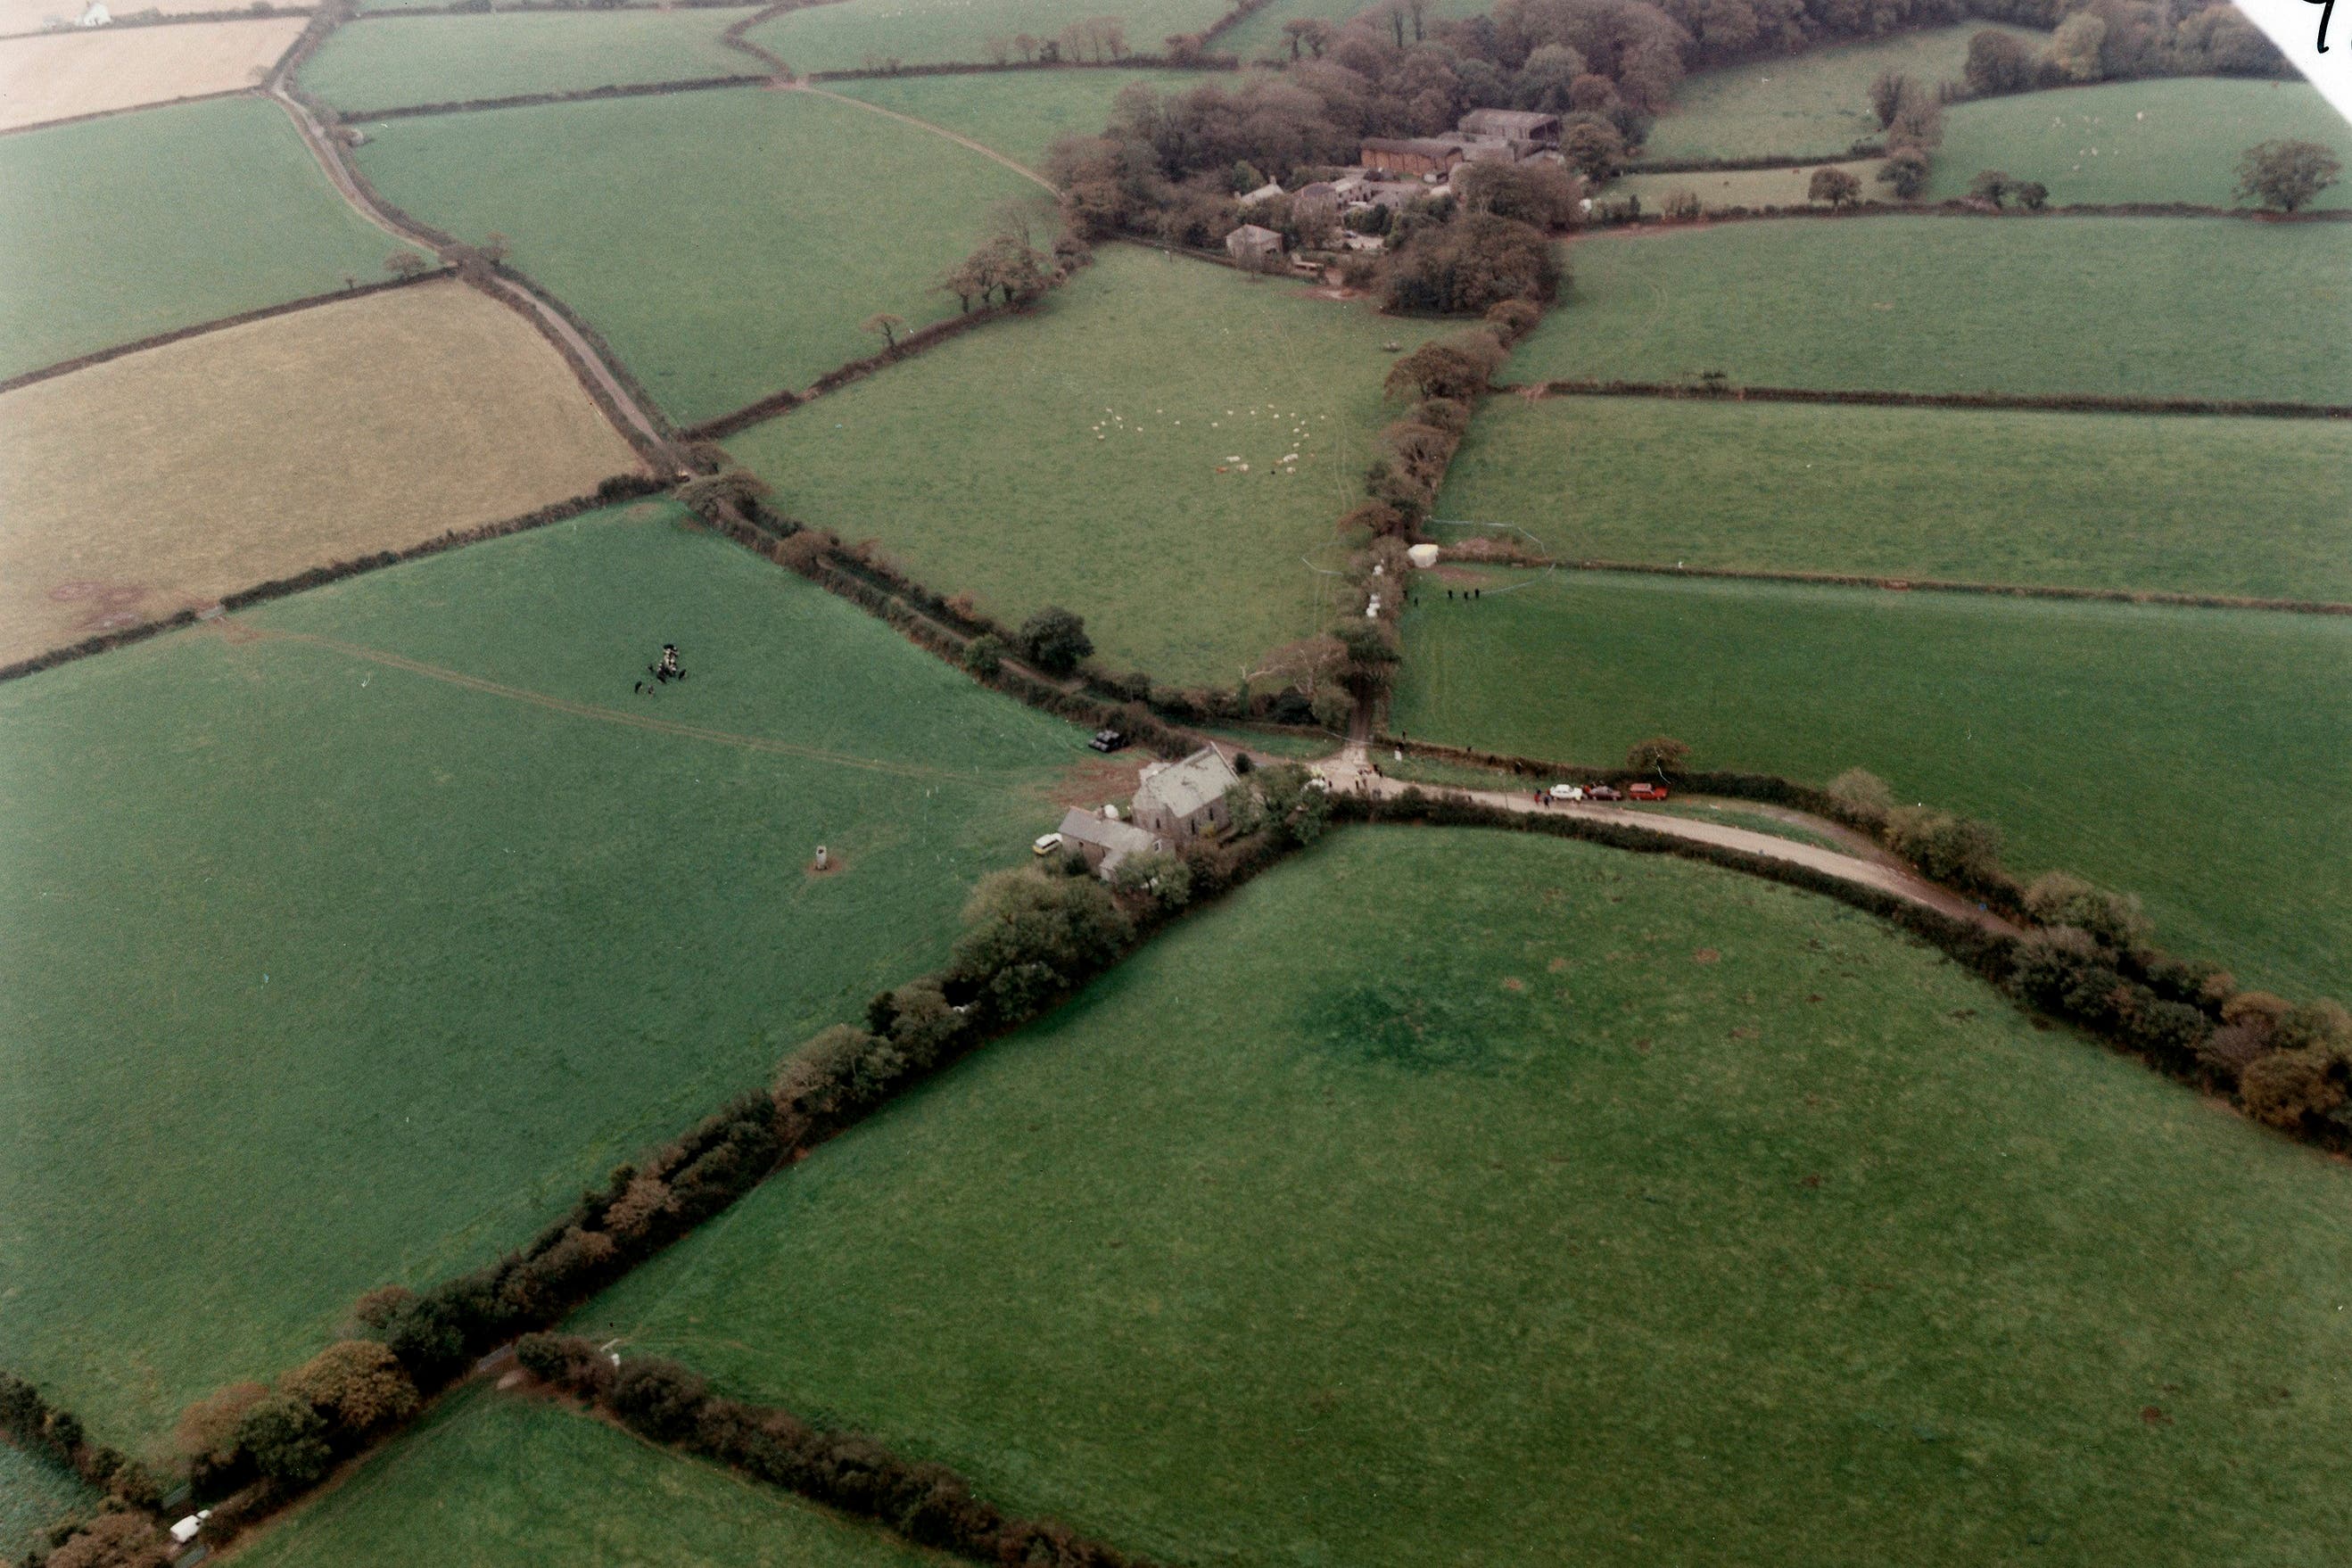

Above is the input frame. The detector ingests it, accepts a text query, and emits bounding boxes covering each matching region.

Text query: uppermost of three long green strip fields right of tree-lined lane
[1503,216,2352,404]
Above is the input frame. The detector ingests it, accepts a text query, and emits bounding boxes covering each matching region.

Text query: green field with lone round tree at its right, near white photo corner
[1927,78,2352,207]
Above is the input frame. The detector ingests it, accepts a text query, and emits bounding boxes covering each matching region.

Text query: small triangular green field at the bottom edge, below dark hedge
[237,1390,950,1568]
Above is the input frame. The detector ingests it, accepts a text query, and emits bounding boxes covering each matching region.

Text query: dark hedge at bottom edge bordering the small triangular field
[516,1333,1150,1568]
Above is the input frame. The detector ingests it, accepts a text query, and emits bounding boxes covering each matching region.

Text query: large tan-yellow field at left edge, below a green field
[0,282,640,663]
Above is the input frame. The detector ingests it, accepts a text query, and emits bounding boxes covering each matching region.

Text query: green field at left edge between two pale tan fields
[0,99,392,378]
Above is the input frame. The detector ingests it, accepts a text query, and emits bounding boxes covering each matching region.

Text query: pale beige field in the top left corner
[0,16,306,132]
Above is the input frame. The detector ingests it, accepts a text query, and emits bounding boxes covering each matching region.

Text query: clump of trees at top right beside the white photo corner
[1961,0,2289,99]
